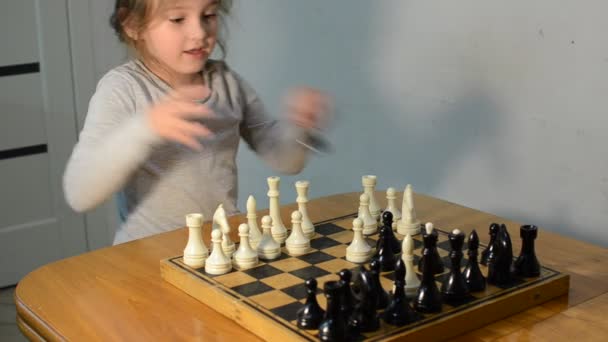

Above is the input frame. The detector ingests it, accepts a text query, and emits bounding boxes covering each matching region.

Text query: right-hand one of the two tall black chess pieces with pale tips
[441,231,469,303]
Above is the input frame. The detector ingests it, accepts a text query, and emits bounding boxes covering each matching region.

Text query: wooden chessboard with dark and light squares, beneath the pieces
[160,214,569,341]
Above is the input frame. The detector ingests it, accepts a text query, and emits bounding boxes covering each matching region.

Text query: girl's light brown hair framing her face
[110,0,232,57]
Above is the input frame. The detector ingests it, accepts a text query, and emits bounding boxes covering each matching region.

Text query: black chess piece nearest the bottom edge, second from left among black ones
[319,280,348,341]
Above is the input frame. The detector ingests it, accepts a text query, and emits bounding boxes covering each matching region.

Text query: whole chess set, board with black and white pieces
[160,176,569,341]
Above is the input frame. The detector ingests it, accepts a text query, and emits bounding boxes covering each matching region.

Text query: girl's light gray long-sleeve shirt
[63,61,308,244]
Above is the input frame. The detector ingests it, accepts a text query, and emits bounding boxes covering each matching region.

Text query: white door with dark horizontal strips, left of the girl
[0,0,87,287]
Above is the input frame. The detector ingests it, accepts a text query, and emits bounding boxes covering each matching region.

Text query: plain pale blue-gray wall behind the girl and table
[88,0,608,246]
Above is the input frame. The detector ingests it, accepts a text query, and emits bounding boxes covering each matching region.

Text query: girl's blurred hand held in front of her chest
[148,86,212,151]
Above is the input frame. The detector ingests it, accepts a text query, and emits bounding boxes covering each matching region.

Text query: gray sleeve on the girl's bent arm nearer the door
[63,74,161,212]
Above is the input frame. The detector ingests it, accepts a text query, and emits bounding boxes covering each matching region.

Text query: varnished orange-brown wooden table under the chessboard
[15,191,608,341]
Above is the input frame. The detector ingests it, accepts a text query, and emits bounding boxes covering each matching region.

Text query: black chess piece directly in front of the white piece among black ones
[383,259,416,326]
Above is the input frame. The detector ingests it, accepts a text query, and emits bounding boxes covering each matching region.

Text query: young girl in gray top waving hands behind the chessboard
[64,0,327,244]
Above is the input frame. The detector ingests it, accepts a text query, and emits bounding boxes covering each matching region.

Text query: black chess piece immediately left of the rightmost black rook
[487,224,513,286]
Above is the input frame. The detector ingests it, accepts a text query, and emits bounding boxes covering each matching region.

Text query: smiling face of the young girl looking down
[138,0,219,86]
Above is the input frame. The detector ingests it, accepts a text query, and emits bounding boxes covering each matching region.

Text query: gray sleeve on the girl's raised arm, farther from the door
[233,72,310,174]
